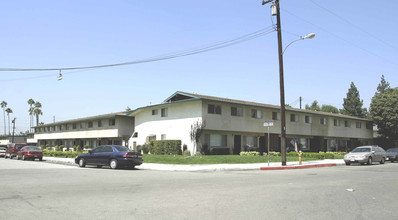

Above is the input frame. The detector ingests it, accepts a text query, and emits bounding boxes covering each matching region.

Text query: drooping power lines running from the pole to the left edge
[0,26,275,72]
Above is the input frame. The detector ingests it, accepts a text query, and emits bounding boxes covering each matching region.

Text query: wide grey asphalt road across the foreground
[0,158,398,220]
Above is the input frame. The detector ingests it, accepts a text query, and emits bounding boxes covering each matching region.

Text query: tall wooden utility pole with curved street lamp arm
[262,0,315,166]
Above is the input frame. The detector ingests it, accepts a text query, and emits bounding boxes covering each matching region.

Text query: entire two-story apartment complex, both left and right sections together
[34,92,373,154]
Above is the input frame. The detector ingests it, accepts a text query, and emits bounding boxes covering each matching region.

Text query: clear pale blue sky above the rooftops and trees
[0,0,398,134]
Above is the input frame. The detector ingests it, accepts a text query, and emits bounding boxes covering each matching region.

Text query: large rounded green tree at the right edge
[370,87,398,144]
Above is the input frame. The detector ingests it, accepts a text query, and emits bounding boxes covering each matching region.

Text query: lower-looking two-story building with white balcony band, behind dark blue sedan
[34,112,134,148]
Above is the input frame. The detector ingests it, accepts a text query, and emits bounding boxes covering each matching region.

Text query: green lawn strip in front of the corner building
[142,154,316,164]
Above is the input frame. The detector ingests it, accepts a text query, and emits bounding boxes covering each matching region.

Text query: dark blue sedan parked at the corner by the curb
[75,145,143,169]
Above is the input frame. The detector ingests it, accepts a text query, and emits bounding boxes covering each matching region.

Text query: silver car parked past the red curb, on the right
[344,145,386,165]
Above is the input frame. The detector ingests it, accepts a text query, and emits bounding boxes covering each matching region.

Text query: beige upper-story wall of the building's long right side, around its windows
[202,101,373,139]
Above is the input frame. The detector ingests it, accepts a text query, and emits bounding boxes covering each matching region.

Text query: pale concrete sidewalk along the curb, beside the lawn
[43,157,345,171]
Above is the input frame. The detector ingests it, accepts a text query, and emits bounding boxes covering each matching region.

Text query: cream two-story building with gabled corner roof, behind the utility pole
[129,92,373,154]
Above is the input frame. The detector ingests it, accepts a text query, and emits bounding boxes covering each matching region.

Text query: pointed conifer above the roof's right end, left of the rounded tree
[340,82,366,118]
